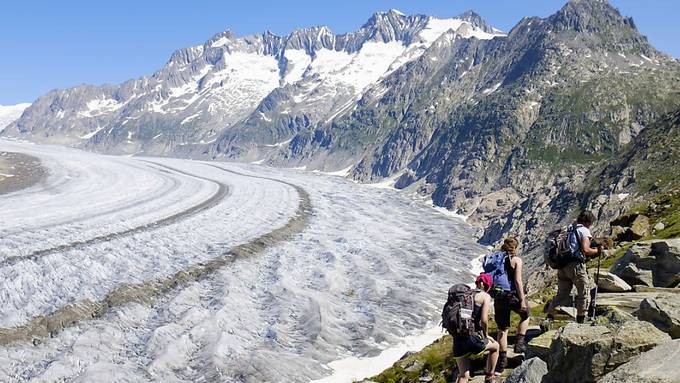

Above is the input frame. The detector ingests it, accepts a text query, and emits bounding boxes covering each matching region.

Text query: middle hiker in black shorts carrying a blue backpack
[483,237,530,372]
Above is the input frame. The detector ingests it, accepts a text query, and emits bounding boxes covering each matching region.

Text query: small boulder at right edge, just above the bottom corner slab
[635,294,680,339]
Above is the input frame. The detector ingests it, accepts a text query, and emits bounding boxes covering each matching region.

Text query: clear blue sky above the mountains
[0,0,680,105]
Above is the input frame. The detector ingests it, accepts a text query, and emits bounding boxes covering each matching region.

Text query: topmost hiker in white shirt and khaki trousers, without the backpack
[541,210,602,331]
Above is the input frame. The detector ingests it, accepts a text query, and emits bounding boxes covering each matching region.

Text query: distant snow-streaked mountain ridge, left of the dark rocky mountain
[6,10,499,157]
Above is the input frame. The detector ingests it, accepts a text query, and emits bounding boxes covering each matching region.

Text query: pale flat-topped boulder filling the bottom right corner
[600,339,680,383]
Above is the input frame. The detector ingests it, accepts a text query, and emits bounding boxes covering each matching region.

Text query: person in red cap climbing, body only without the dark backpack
[453,274,498,383]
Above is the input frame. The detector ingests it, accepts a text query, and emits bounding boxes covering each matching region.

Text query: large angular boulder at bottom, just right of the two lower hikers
[545,320,670,383]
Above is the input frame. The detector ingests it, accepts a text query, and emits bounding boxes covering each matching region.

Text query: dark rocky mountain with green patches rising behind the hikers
[270,0,680,278]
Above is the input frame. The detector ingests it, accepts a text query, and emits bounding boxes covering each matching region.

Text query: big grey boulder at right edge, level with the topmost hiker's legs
[611,239,680,287]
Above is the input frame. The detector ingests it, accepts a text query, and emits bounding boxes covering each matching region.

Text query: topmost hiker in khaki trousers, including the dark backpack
[541,210,602,331]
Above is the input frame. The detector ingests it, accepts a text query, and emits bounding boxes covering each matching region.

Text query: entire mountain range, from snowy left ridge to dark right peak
[1,0,680,270]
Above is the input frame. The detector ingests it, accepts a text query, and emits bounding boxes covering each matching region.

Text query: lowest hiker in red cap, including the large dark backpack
[442,274,498,383]
